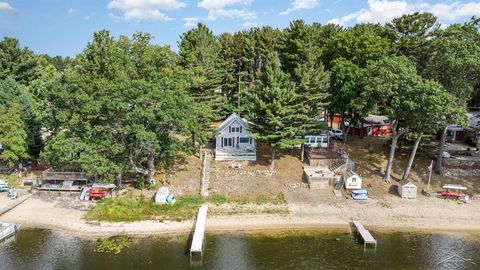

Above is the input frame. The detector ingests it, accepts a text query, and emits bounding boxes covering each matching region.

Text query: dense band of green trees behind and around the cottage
[0,13,480,184]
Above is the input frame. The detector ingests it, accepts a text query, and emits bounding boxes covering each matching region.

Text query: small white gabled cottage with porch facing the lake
[215,113,257,161]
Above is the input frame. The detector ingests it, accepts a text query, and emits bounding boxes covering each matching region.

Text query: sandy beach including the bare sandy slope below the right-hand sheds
[0,190,480,237]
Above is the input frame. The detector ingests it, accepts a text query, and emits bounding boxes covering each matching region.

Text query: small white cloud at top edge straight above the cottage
[198,0,257,21]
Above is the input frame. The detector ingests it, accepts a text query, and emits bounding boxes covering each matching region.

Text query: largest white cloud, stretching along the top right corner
[329,0,480,25]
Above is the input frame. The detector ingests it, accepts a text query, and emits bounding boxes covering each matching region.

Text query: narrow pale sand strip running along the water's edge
[0,198,480,238]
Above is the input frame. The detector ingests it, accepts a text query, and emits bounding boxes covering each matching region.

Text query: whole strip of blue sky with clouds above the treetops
[0,0,480,56]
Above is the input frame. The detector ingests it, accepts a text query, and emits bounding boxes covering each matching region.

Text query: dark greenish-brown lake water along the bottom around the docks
[0,229,480,270]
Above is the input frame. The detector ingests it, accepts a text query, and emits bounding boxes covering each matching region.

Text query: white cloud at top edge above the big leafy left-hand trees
[107,0,186,21]
